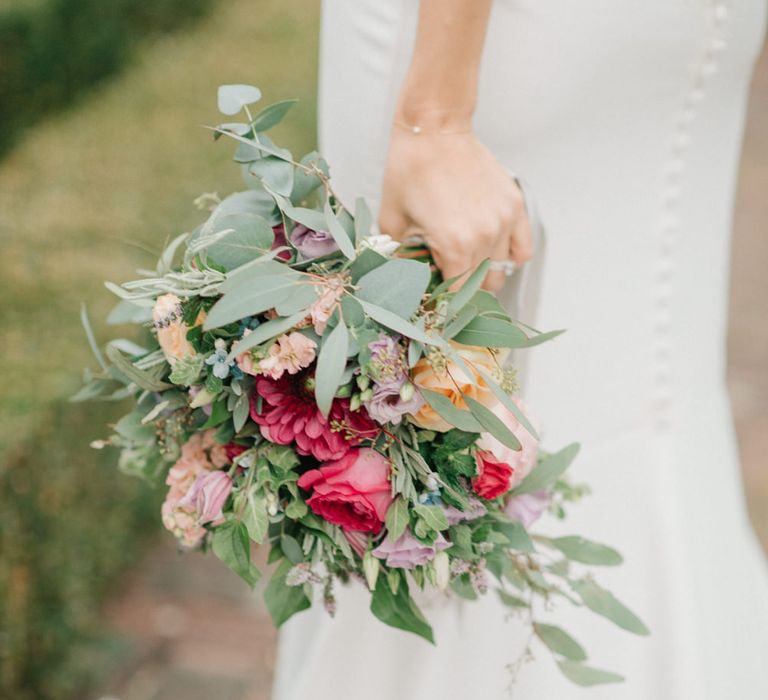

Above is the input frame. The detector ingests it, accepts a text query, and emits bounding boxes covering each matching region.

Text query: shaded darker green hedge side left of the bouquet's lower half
[0,402,160,700]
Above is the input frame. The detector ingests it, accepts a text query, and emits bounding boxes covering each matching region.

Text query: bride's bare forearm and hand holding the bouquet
[379,0,532,289]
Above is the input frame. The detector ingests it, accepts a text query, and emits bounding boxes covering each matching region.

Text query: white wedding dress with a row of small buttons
[273,0,768,700]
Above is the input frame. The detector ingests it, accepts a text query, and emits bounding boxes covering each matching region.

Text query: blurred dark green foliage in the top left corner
[0,0,212,153]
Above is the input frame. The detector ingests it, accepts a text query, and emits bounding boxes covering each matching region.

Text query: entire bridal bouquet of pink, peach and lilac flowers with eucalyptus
[76,86,646,685]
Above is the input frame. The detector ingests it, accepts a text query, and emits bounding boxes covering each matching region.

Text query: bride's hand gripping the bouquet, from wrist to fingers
[379,124,533,290]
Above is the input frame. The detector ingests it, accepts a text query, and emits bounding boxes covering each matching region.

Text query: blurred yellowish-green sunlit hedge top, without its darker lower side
[0,0,318,458]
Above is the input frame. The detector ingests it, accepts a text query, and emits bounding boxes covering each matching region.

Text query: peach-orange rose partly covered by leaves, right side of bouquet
[412,342,501,433]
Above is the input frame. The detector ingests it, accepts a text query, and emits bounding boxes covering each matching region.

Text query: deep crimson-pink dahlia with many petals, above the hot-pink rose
[251,375,378,462]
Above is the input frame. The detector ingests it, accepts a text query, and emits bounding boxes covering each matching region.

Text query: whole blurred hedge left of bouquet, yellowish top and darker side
[0,0,319,700]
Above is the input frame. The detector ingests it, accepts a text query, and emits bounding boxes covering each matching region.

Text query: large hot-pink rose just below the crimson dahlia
[298,448,392,534]
